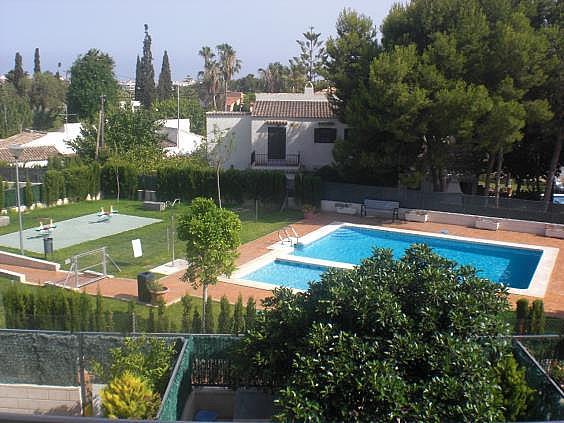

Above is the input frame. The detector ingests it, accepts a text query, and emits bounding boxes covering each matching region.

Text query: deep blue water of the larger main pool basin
[290,226,542,289]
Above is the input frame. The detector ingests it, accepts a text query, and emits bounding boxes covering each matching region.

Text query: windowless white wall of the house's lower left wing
[206,112,252,169]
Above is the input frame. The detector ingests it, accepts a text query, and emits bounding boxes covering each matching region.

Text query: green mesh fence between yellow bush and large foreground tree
[157,335,239,422]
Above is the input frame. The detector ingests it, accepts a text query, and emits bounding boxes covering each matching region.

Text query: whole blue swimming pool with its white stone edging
[232,222,558,297]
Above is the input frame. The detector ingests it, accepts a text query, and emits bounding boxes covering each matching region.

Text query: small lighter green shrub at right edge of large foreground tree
[495,355,535,422]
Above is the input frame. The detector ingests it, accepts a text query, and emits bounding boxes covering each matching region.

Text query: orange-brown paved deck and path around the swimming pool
[4,213,564,317]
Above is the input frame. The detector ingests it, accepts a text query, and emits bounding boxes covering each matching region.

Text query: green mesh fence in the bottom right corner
[513,337,564,420]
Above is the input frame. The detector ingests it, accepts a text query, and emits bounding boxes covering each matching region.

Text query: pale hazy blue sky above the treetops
[0,0,397,80]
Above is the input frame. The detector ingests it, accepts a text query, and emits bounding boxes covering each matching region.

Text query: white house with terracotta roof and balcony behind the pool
[206,85,345,173]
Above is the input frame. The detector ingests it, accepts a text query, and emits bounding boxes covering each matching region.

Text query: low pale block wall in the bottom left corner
[0,383,82,416]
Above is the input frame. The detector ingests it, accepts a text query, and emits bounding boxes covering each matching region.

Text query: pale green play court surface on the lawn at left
[0,213,160,253]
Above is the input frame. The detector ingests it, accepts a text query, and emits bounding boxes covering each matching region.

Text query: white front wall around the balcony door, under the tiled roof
[252,118,346,170]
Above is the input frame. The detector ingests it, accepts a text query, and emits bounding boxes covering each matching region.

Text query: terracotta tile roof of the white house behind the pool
[253,100,337,119]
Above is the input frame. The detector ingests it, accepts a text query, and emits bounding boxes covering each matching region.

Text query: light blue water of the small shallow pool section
[242,260,327,290]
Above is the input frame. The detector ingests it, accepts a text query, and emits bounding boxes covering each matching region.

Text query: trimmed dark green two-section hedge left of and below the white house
[157,164,286,204]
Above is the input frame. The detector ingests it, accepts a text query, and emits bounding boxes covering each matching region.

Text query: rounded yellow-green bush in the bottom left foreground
[100,371,160,420]
